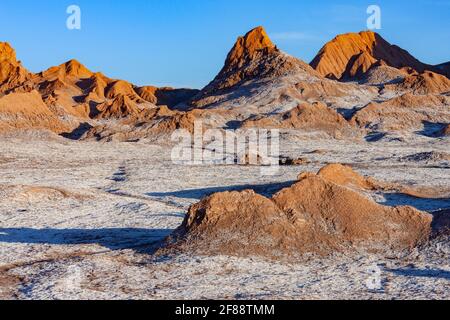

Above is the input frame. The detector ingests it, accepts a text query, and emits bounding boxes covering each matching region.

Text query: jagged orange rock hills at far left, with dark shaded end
[0,43,197,133]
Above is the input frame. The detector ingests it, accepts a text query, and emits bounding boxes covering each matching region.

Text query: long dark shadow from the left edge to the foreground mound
[0,228,173,253]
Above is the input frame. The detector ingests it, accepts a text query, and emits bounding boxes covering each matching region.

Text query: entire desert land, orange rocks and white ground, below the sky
[0,27,450,300]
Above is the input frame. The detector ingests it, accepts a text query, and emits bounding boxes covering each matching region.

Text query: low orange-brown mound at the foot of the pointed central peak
[242,103,354,137]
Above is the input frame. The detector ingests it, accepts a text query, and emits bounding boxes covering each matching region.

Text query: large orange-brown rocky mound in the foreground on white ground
[174,166,432,257]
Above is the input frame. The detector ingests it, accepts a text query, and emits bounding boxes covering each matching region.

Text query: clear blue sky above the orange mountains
[0,0,450,88]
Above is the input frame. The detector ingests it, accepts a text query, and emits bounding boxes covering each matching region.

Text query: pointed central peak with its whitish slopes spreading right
[190,27,378,126]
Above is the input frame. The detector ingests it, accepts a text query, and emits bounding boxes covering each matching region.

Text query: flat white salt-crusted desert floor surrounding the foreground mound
[0,131,450,299]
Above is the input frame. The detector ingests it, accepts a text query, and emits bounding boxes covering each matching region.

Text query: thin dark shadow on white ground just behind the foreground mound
[146,181,296,200]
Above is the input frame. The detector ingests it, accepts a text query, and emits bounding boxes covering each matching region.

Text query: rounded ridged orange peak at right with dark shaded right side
[311,31,431,80]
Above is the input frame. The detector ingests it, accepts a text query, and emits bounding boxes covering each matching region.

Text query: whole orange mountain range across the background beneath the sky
[0,27,450,140]
